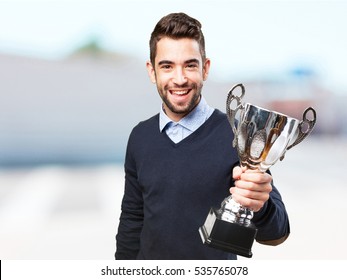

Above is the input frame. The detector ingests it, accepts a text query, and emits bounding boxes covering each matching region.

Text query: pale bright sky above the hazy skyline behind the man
[0,0,347,93]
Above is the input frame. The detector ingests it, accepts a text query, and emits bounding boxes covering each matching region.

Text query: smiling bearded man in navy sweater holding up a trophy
[115,13,289,259]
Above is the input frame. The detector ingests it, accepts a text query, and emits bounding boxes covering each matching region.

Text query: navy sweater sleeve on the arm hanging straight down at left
[115,132,143,260]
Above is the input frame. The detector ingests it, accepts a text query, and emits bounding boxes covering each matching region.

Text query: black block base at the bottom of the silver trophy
[199,208,257,258]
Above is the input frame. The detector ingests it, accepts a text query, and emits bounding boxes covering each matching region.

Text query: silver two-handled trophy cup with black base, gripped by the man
[199,84,316,258]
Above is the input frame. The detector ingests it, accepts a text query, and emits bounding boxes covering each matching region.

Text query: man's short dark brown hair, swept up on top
[149,13,206,66]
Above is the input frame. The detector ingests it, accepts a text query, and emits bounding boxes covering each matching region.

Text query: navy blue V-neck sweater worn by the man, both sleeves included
[115,110,289,260]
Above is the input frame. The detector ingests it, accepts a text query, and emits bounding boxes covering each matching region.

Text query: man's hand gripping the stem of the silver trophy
[230,166,272,212]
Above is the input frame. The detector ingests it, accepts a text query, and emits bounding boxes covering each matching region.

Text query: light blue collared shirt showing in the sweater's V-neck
[159,96,214,143]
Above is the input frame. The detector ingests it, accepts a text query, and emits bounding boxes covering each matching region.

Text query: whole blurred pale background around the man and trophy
[0,0,347,260]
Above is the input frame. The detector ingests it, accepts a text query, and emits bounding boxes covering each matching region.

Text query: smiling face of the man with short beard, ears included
[147,37,210,121]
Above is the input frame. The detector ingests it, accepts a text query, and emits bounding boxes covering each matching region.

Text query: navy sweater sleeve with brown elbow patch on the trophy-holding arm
[252,178,290,245]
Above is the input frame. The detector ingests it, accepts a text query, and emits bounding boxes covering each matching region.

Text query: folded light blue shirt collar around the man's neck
[159,96,212,132]
